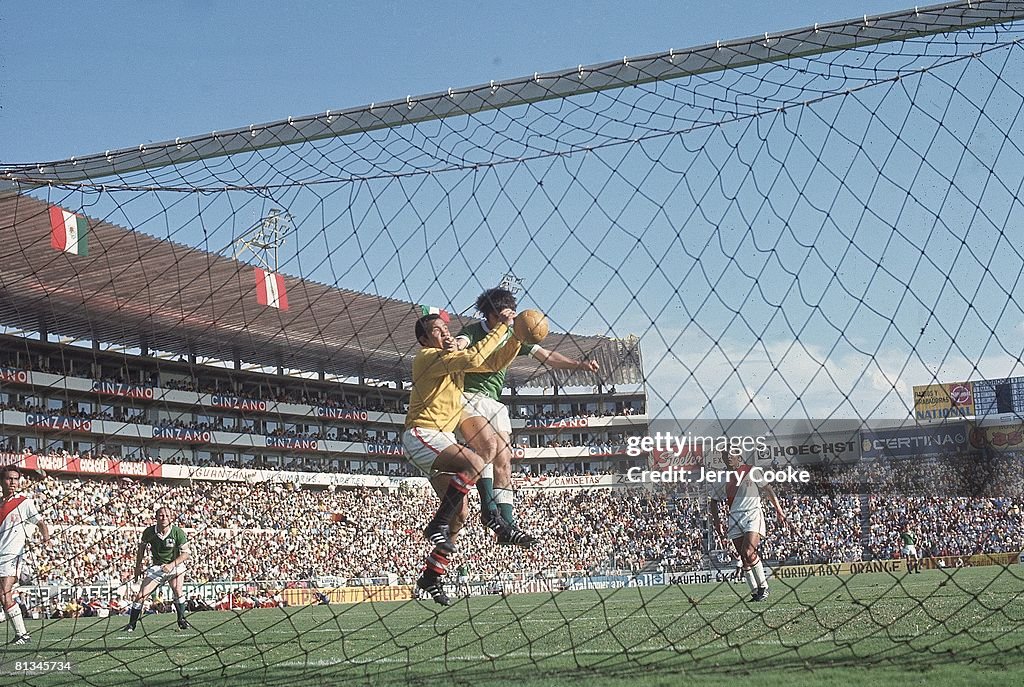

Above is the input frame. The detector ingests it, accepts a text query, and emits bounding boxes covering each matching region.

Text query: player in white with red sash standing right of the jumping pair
[711,450,788,601]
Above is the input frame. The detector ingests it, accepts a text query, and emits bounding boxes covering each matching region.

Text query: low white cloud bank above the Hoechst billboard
[641,330,1024,419]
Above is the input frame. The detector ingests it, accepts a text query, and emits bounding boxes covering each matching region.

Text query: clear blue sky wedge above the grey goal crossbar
[0,0,909,163]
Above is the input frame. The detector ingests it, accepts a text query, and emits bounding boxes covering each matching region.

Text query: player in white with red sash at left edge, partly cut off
[0,466,50,644]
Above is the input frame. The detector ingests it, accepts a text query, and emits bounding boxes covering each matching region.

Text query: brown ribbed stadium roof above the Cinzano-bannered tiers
[0,194,643,387]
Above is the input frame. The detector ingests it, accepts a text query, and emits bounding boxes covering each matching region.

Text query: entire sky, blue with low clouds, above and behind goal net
[0,2,1024,418]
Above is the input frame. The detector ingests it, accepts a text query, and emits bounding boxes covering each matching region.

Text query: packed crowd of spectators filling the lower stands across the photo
[12,456,1024,585]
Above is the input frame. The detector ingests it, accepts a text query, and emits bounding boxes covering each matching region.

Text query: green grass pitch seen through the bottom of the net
[0,566,1024,687]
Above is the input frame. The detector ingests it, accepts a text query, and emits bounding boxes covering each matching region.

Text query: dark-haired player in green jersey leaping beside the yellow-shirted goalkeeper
[456,289,599,547]
